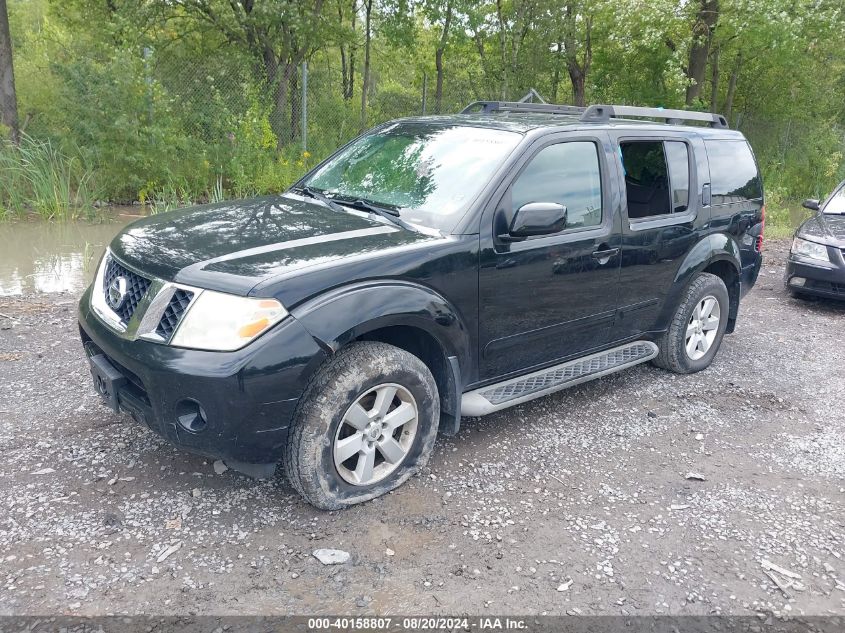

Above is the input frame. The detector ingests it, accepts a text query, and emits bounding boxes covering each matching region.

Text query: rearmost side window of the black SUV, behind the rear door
[704,140,763,205]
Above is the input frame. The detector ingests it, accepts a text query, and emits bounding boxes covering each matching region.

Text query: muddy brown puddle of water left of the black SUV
[0,209,139,295]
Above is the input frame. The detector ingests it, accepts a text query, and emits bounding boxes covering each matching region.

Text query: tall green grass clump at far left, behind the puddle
[0,135,96,220]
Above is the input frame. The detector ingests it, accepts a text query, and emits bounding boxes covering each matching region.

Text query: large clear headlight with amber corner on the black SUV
[170,290,288,352]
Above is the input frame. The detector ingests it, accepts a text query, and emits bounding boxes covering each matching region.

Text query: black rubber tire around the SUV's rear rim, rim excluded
[651,273,730,374]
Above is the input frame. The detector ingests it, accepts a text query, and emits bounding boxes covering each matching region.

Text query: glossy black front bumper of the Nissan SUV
[79,288,325,464]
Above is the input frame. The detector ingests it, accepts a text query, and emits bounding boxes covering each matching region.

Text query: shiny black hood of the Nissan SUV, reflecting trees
[111,195,434,295]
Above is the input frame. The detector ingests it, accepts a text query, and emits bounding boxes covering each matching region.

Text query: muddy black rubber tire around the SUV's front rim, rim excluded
[282,342,440,510]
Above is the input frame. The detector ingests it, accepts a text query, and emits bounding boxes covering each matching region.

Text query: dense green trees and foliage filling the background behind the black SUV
[0,0,845,207]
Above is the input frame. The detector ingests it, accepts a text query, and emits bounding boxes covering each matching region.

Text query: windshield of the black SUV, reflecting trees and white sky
[296,122,522,231]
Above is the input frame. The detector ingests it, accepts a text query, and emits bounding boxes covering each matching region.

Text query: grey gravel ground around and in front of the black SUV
[0,241,845,615]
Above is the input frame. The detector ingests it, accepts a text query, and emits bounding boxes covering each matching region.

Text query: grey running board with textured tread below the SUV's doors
[461,341,658,417]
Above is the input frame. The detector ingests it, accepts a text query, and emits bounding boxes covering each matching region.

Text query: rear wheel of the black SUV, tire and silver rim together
[652,273,730,374]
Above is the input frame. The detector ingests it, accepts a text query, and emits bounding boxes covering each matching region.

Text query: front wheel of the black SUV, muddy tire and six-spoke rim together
[283,342,440,510]
